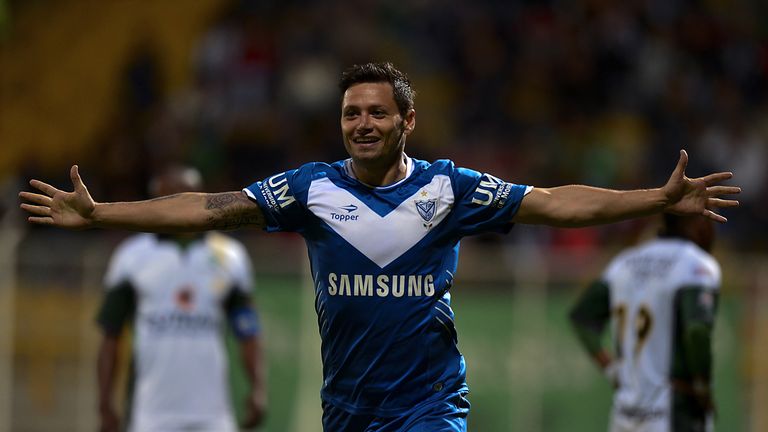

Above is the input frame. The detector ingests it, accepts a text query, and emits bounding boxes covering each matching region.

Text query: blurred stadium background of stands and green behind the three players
[0,0,768,432]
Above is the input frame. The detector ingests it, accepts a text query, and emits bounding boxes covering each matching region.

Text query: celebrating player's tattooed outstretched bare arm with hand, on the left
[19,165,264,232]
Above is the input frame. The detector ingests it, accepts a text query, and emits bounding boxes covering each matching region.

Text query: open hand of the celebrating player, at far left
[19,165,96,229]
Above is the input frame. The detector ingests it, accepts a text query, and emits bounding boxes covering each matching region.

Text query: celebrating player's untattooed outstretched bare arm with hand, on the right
[512,150,741,227]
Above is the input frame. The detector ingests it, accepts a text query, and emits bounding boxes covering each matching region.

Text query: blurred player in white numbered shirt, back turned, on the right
[571,214,720,432]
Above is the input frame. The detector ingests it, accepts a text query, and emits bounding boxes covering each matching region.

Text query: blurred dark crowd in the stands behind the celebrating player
[15,0,768,251]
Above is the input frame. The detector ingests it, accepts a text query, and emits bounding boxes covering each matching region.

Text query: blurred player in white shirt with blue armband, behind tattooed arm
[97,166,266,432]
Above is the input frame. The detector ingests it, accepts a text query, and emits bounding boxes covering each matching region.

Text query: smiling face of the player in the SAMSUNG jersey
[341,82,416,171]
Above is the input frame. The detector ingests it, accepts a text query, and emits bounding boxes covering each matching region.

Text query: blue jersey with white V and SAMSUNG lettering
[244,158,531,416]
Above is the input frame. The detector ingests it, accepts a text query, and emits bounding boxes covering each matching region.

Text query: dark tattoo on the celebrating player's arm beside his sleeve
[205,192,265,230]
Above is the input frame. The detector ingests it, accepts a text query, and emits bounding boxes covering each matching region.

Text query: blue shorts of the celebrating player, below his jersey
[323,392,469,432]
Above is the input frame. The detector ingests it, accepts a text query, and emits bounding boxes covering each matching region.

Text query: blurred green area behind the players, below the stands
[230,277,747,432]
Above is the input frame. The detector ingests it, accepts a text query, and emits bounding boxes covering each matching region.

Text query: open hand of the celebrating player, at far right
[662,150,741,222]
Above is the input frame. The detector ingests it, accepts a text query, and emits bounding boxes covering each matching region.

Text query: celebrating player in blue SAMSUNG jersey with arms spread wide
[20,63,739,432]
